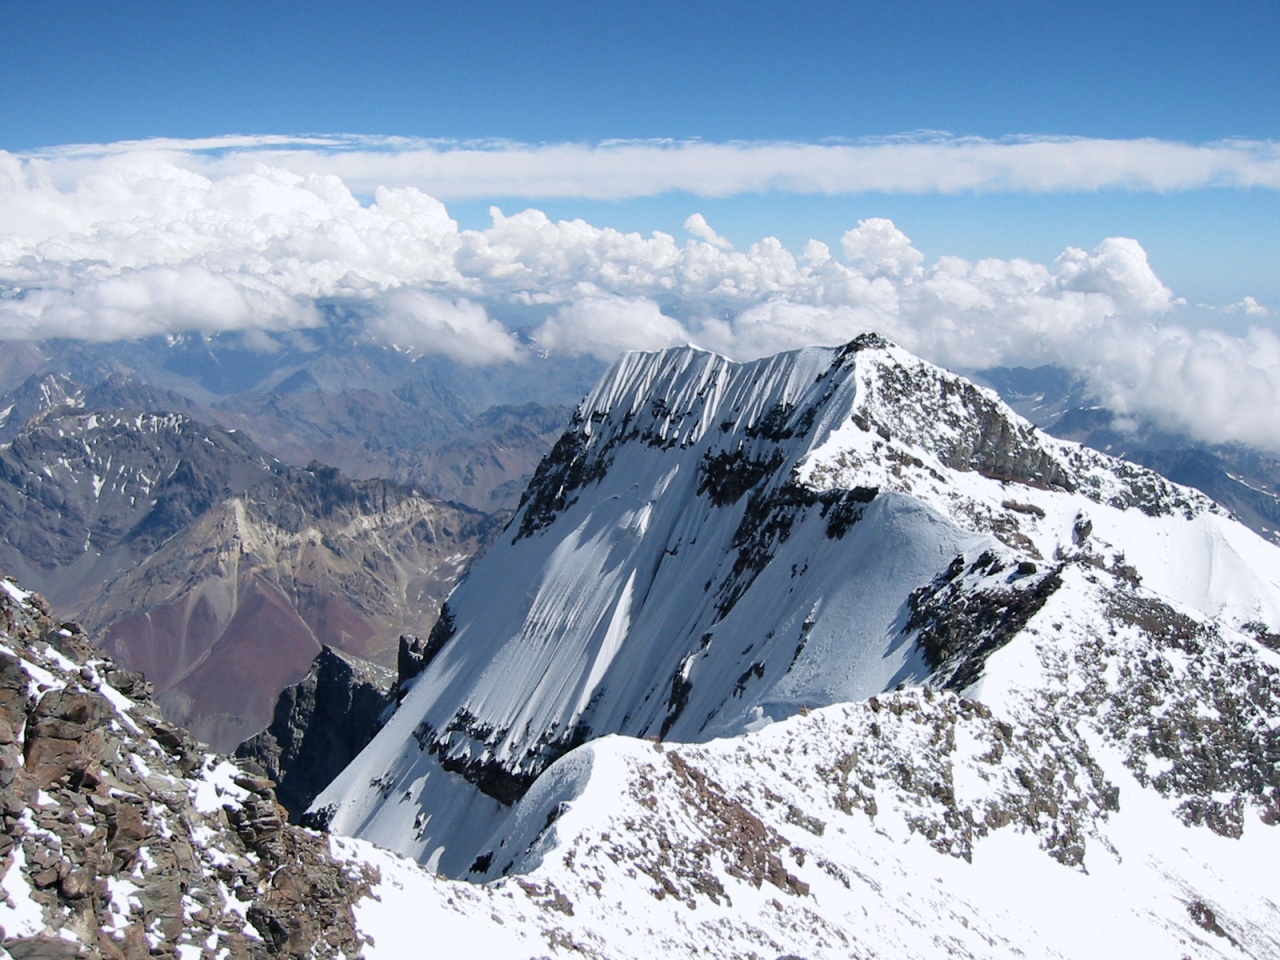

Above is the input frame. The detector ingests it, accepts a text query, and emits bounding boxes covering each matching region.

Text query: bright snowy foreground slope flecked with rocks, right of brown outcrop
[334,552,1280,960]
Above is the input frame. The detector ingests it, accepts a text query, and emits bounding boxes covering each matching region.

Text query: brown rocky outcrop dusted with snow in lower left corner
[0,582,374,960]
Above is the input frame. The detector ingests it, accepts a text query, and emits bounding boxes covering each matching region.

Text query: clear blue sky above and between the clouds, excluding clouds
[0,0,1280,306]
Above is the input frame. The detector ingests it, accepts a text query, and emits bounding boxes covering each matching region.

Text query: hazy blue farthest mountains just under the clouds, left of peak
[0,323,586,511]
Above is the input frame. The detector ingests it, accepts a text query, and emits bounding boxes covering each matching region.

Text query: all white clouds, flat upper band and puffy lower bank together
[0,138,1280,451]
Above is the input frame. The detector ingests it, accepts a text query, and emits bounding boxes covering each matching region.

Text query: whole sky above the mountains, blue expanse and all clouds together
[0,0,1280,449]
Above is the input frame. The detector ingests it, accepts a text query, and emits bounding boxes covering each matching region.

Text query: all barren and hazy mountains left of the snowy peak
[0,323,596,750]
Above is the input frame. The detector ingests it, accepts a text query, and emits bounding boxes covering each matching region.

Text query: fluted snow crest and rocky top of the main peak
[518,334,1216,545]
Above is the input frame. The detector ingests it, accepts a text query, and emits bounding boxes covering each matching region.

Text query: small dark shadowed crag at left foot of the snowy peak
[236,646,394,823]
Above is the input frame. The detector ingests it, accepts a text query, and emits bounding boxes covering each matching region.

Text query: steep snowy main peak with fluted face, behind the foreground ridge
[309,337,1280,876]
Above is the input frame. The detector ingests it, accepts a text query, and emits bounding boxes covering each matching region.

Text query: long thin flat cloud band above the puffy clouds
[17,134,1280,201]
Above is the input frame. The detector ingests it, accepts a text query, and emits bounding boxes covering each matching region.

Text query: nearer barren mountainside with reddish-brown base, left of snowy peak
[0,408,502,750]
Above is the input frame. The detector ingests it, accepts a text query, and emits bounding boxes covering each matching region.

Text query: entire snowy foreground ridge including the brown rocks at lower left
[0,558,1280,960]
